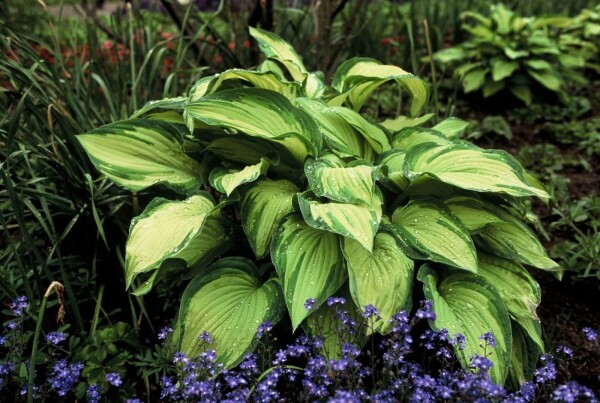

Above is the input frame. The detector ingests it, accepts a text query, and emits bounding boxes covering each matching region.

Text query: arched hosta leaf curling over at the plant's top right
[332,57,429,116]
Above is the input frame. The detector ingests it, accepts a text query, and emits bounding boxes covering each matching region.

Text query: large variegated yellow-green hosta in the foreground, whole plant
[79,29,560,383]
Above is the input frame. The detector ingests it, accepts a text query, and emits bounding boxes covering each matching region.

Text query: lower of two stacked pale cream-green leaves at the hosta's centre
[298,191,382,251]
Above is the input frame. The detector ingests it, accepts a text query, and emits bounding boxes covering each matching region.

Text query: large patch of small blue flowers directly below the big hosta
[149,298,597,403]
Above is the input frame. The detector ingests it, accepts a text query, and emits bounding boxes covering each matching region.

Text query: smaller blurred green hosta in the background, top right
[434,4,597,105]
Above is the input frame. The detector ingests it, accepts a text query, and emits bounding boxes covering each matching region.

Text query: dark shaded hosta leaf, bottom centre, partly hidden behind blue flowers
[302,285,368,360]
